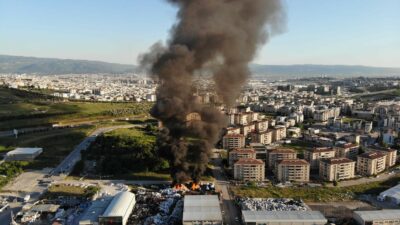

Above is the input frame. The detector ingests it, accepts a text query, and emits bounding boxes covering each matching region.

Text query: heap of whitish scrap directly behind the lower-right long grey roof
[238,198,308,211]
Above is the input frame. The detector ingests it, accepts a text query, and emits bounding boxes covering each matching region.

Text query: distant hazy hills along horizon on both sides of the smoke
[0,55,400,79]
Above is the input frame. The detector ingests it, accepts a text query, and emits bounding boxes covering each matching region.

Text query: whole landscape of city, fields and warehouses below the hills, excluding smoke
[0,74,400,225]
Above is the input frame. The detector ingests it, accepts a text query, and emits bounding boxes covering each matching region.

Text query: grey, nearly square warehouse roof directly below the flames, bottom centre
[183,195,222,221]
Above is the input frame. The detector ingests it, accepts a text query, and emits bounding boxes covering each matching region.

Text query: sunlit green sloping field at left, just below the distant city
[0,88,152,131]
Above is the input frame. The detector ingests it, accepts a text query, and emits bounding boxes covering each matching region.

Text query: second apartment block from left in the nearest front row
[276,159,310,182]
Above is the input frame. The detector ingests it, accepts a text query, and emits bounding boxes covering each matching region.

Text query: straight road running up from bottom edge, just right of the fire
[213,158,241,225]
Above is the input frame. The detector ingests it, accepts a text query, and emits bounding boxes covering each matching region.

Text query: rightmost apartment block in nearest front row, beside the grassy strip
[357,151,386,176]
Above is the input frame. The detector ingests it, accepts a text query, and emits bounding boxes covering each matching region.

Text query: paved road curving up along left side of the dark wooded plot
[51,125,141,175]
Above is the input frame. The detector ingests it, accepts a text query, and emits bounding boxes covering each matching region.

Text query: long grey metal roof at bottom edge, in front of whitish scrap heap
[242,210,327,224]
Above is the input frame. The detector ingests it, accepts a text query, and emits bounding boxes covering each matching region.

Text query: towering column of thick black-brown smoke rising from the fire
[141,0,284,182]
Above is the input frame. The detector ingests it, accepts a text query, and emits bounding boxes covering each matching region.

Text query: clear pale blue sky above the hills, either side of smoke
[0,0,400,67]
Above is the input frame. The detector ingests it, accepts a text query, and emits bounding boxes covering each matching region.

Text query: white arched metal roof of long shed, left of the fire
[102,191,135,217]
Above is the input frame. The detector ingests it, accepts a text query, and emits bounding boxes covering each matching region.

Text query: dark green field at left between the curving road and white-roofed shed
[0,126,95,169]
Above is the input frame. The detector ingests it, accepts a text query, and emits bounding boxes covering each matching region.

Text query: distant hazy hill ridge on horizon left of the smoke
[0,55,135,74]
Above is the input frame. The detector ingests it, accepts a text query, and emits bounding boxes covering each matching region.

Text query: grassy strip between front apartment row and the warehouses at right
[232,176,400,202]
